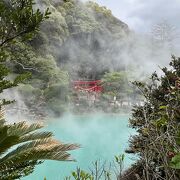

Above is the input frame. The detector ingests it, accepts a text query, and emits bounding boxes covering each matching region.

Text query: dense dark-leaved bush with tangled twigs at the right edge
[128,56,180,180]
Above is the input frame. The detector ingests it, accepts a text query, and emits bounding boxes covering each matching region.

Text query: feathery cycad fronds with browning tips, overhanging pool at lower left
[0,111,79,180]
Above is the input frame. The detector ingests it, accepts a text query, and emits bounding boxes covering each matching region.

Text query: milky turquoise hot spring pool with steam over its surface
[23,114,135,180]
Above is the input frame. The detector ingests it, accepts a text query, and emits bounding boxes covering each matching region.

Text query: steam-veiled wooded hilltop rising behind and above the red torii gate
[31,1,129,79]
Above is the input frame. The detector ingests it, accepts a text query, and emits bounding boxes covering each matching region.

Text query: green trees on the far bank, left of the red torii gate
[4,38,69,115]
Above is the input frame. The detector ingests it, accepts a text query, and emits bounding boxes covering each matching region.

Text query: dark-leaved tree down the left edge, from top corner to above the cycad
[0,0,50,106]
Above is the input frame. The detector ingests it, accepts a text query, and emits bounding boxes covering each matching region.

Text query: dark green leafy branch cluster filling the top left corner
[0,0,50,47]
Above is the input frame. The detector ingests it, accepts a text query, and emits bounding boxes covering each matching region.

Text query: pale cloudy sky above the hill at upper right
[89,0,180,33]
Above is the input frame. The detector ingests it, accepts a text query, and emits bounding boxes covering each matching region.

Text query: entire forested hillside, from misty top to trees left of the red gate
[5,0,130,114]
